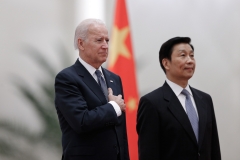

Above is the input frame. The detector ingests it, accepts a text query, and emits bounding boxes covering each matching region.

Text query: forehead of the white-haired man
[88,24,108,37]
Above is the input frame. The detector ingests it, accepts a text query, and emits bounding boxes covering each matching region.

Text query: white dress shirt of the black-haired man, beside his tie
[166,79,198,119]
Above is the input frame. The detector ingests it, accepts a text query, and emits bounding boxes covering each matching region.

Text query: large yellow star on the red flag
[109,26,131,68]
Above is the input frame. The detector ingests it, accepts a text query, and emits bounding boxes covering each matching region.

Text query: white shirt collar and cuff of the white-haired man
[78,56,122,117]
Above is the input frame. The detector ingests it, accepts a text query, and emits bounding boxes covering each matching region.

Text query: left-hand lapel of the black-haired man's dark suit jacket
[163,82,198,145]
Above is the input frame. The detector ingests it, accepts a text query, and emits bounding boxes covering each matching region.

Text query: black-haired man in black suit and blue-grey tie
[137,37,221,160]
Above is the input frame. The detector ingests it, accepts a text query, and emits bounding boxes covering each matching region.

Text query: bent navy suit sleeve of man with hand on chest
[55,72,117,133]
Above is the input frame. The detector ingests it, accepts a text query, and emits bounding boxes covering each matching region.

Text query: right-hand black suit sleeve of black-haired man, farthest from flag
[210,97,221,160]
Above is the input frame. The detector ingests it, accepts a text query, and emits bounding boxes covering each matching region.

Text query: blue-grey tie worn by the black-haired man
[182,89,198,141]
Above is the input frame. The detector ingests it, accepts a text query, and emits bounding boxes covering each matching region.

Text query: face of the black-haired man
[165,43,195,83]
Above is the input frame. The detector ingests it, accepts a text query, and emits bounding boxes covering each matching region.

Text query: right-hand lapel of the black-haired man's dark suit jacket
[190,87,207,148]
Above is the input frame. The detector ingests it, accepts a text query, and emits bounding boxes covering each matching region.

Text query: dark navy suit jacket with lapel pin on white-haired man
[55,60,129,160]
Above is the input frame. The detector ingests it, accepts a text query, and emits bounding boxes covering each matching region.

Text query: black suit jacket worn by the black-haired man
[137,82,221,160]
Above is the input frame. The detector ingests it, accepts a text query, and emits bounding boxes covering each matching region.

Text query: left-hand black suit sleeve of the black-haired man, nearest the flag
[137,97,160,160]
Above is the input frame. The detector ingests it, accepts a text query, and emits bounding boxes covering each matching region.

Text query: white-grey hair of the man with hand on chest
[74,19,106,49]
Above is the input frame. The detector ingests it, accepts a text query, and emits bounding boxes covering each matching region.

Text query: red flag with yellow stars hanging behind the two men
[108,0,139,160]
